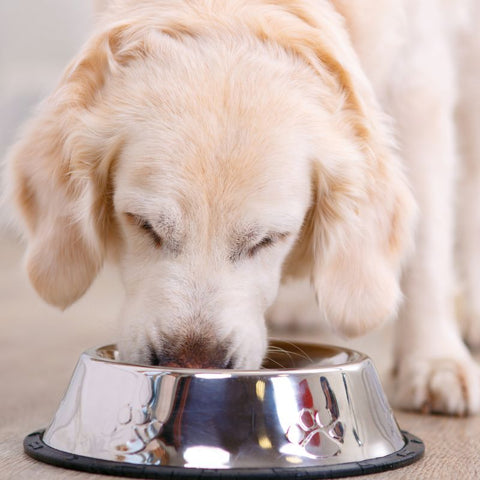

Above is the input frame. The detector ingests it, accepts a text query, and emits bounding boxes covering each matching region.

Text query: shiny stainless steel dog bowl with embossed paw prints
[25,342,423,479]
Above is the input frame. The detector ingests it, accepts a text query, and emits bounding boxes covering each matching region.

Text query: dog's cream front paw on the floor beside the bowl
[388,355,480,416]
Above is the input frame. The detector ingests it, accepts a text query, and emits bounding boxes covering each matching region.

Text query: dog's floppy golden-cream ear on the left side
[7,29,129,308]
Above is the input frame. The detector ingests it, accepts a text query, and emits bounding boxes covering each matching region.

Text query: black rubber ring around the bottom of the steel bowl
[23,430,425,480]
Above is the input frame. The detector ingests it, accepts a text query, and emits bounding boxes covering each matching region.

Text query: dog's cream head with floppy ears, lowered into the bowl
[10,2,413,368]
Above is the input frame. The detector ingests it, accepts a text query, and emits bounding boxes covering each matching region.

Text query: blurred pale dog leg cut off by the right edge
[457,2,480,349]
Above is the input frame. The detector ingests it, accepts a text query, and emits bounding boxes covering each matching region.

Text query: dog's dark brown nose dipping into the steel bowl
[148,335,234,368]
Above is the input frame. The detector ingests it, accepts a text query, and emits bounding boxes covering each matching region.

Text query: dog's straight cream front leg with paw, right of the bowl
[390,2,480,415]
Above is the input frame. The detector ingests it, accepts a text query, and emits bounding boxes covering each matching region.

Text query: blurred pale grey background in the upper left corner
[0,0,93,231]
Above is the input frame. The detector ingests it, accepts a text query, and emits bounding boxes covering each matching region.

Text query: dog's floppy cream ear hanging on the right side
[285,152,415,336]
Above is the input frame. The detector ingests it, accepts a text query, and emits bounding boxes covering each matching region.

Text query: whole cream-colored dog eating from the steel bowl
[9,0,480,414]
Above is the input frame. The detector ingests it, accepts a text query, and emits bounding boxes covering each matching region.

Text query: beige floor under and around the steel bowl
[0,237,480,480]
